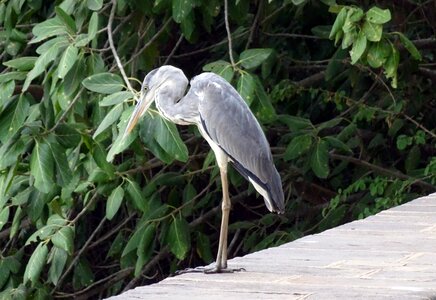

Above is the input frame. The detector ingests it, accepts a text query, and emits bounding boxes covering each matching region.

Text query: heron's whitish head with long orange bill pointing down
[124,66,188,137]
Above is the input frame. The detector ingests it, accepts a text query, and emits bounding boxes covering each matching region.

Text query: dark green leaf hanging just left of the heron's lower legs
[167,217,191,260]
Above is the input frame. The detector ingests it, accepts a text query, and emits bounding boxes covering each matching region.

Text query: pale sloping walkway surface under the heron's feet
[110,194,436,300]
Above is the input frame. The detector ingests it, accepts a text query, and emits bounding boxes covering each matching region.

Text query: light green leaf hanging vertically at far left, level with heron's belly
[30,141,54,193]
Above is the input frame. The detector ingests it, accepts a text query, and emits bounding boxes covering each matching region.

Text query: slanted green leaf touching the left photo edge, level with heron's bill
[0,94,29,144]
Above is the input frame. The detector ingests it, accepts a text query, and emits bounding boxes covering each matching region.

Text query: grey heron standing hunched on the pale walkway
[125,66,285,273]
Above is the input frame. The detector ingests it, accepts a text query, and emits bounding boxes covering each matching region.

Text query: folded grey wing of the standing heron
[195,73,284,212]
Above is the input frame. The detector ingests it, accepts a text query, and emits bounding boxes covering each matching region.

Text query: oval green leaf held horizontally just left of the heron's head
[82,73,124,94]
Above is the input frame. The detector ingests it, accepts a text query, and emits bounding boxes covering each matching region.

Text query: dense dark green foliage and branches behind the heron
[0,0,436,299]
